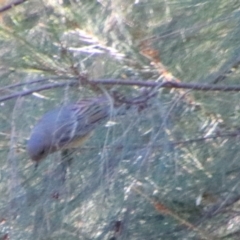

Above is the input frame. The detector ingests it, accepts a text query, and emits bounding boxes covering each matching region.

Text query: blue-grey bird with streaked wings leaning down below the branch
[27,96,119,164]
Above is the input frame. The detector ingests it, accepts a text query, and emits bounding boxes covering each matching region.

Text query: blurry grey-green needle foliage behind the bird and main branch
[0,0,240,240]
